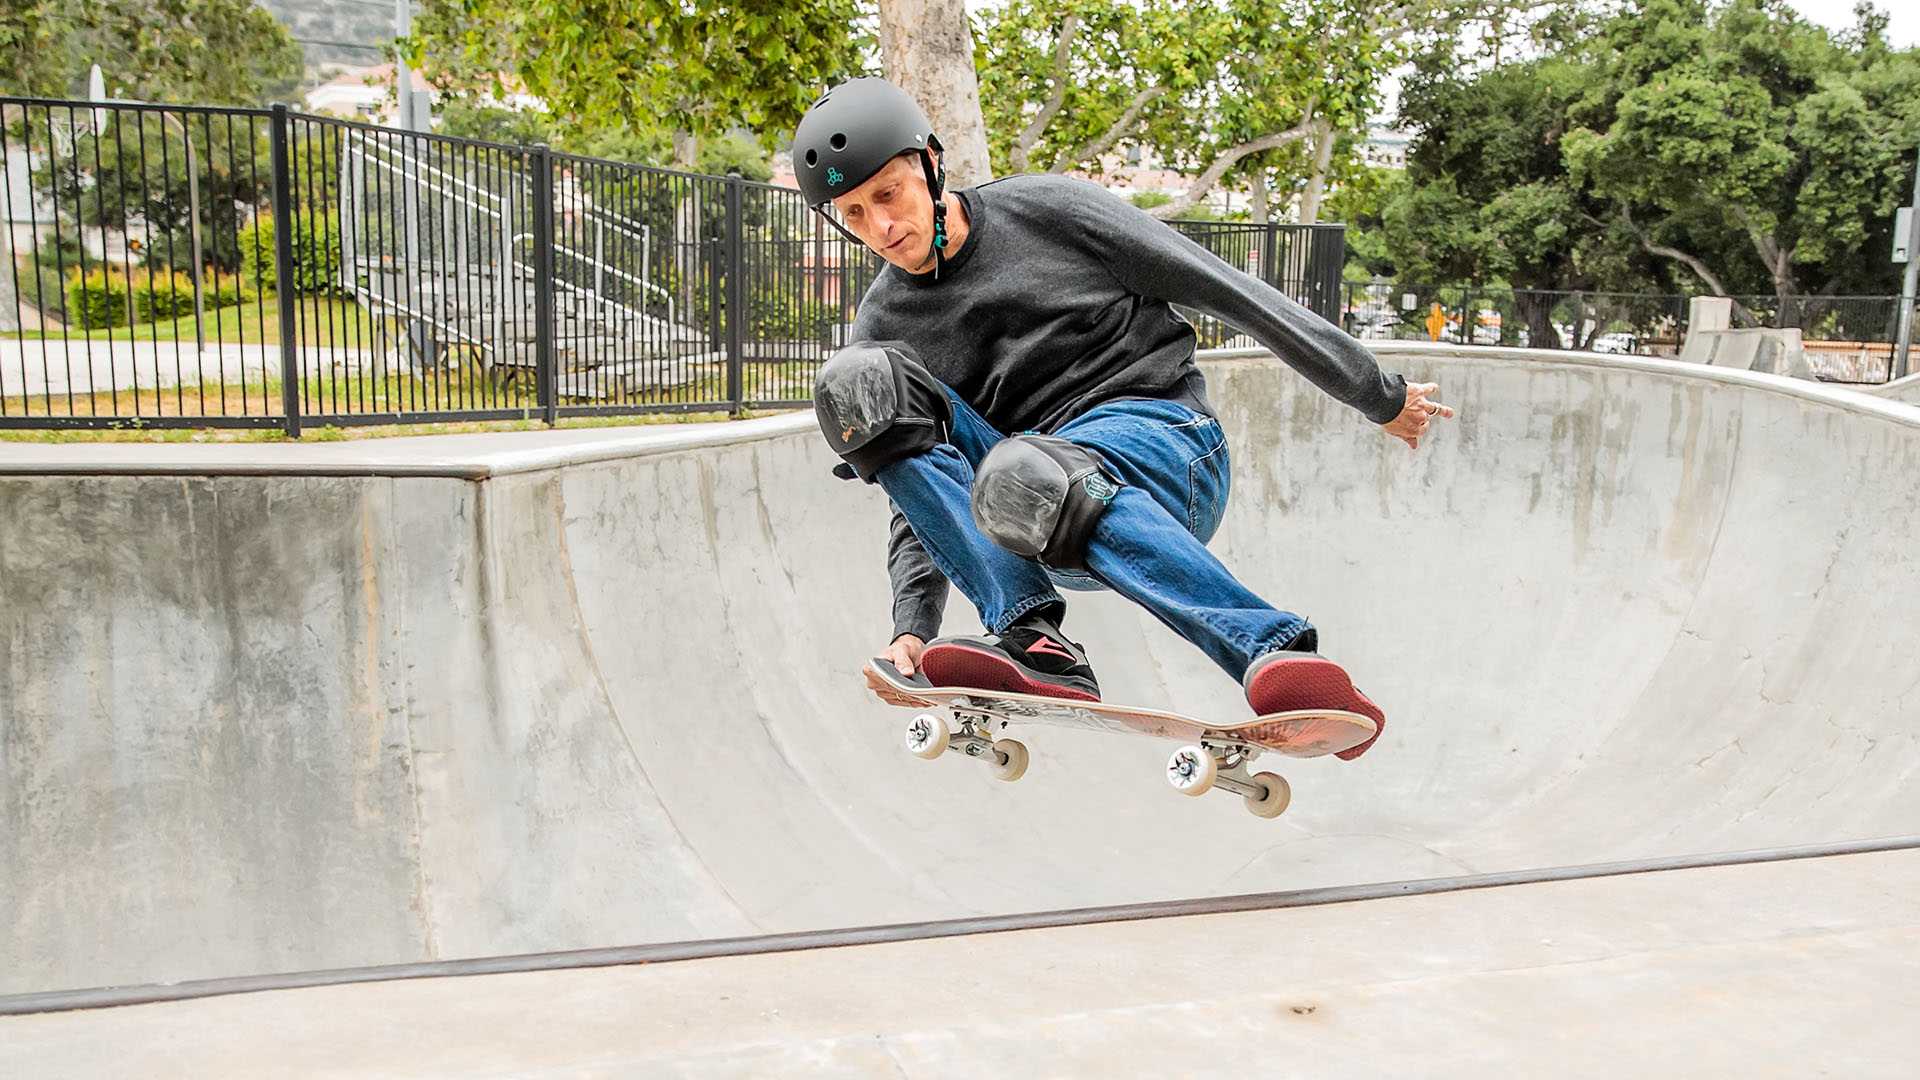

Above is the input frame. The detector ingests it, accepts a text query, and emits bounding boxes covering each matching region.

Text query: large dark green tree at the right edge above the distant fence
[1565,0,1920,311]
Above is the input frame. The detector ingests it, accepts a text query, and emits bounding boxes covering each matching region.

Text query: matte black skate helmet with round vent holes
[793,79,941,206]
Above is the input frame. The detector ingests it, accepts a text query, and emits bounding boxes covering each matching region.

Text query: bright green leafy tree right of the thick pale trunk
[975,0,1543,221]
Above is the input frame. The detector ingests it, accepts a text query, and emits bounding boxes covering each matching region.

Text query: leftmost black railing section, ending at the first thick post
[0,100,280,427]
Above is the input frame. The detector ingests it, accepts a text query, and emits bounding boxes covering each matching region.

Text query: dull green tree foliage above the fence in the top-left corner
[0,0,301,106]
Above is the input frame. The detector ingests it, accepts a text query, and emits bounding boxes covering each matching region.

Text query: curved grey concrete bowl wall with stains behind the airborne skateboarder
[0,346,1920,992]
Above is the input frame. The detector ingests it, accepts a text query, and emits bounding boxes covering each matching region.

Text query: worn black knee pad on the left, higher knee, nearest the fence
[814,342,954,484]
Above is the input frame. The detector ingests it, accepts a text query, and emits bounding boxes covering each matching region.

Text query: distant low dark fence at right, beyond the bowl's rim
[1340,282,1901,382]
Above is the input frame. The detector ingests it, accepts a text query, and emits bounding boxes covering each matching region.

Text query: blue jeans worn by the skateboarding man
[876,390,1308,678]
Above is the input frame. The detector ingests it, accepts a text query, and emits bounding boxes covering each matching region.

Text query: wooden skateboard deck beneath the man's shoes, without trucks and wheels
[866,657,1375,757]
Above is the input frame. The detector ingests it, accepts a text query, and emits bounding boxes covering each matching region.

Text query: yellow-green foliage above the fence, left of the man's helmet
[403,0,860,167]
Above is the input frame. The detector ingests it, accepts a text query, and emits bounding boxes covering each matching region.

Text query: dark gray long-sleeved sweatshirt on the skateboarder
[851,175,1405,638]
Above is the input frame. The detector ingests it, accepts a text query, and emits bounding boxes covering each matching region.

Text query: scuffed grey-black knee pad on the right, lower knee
[973,434,1123,571]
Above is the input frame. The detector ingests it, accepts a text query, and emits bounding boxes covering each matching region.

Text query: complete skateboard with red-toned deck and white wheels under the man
[864,657,1375,817]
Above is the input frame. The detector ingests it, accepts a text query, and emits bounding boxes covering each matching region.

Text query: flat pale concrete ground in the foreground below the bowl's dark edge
[0,851,1920,1080]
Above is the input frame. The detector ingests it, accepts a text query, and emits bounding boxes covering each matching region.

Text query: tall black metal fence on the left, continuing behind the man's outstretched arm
[0,98,1344,434]
